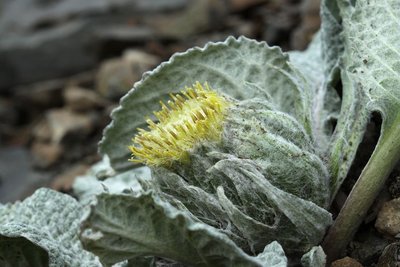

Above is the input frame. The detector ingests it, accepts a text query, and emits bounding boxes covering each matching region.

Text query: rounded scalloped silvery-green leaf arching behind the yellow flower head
[100,37,310,170]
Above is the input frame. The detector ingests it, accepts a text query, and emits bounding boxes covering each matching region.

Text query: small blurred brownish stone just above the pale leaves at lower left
[50,164,90,192]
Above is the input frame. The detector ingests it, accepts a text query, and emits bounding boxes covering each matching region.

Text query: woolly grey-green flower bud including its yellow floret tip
[130,82,329,253]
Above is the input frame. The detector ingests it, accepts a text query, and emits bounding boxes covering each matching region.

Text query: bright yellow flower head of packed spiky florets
[129,82,229,167]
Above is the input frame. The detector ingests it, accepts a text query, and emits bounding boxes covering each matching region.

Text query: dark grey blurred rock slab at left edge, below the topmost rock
[0,20,99,91]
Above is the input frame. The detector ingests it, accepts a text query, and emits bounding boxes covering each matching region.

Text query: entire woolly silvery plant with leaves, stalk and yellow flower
[0,0,400,266]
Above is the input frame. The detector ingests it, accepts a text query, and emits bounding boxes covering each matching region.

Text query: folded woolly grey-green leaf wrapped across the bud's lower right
[210,158,332,255]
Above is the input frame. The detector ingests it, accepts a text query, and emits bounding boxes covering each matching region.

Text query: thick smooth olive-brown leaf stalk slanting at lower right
[322,113,400,262]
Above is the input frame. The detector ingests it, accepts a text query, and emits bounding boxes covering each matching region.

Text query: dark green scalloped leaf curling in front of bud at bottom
[81,191,282,266]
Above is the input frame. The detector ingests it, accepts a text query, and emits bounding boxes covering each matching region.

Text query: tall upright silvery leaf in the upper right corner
[291,0,400,201]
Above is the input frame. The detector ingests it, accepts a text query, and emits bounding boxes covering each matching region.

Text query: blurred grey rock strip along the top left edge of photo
[0,0,189,35]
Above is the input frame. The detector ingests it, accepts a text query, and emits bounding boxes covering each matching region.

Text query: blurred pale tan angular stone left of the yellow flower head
[46,109,95,144]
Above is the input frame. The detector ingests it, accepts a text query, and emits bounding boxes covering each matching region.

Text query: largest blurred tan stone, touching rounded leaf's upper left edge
[96,50,160,100]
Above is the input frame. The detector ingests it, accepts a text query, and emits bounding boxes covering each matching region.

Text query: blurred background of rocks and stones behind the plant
[0,0,320,203]
